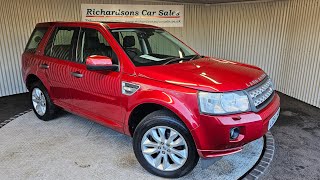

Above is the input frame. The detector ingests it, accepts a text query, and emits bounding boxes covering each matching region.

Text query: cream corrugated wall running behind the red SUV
[0,0,320,107]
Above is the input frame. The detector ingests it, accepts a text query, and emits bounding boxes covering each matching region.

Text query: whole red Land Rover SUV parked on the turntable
[22,22,280,177]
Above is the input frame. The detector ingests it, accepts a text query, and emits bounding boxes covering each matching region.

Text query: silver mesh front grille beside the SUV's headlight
[248,77,274,109]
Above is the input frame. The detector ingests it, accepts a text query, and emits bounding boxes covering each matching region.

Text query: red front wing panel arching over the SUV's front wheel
[122,75,200,135]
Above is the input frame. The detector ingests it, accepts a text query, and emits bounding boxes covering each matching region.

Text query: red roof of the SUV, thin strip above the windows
[37,21,161,29]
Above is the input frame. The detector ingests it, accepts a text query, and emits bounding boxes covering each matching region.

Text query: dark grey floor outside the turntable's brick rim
[0,93,320,180]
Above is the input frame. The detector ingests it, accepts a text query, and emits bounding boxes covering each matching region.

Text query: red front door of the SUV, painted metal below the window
[67,63,123,131]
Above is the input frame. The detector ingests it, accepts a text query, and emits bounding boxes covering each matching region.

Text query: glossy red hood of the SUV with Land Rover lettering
[136,58,266,92]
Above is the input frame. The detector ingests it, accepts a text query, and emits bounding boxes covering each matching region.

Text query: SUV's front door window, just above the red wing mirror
[77,28,118,64]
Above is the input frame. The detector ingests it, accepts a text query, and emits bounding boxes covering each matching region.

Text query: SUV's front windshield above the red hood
[111,28,198,66]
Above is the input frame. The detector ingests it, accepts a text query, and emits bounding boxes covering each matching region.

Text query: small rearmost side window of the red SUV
[25,27,48,53]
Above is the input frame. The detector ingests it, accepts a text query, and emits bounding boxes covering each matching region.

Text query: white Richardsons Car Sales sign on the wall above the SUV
[81,4,184,27]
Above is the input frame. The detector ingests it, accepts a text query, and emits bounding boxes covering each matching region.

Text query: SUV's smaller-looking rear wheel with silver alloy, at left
[30,82,57,121]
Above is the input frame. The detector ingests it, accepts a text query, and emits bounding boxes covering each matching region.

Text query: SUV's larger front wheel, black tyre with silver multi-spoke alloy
[133,110,199,178]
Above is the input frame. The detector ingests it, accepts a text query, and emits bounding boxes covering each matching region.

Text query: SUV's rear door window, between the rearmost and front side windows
[45,28,79,60]
